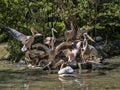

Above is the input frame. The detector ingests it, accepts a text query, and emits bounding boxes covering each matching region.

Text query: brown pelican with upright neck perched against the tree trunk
[65,22,75,41]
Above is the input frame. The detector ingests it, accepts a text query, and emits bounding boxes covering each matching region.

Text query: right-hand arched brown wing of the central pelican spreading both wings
[55,42,74,54]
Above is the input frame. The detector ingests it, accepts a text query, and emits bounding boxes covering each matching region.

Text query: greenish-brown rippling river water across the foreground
[0,56,120,90]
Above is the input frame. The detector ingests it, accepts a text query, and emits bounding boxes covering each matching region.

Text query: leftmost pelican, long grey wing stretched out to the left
[3,26,41,52]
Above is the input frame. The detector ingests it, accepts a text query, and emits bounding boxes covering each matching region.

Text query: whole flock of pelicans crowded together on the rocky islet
[4,23,100,75]
